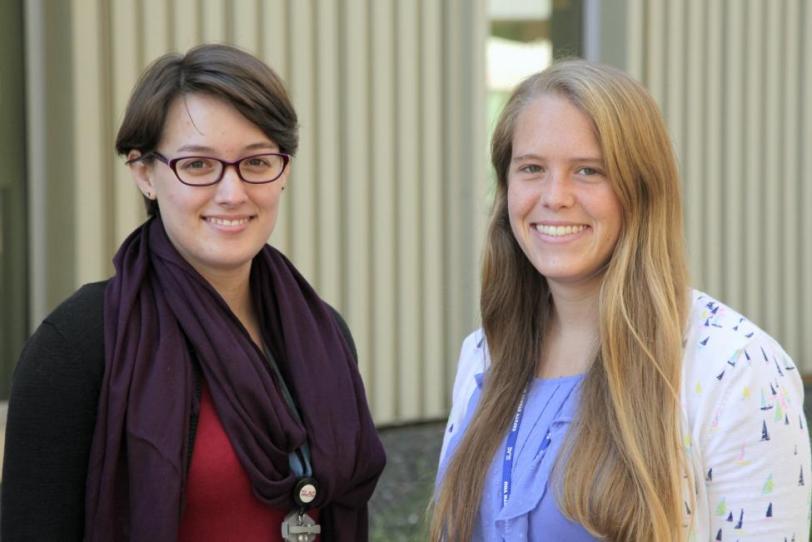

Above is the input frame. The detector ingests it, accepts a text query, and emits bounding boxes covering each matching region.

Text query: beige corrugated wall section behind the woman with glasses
[26,0,487,424]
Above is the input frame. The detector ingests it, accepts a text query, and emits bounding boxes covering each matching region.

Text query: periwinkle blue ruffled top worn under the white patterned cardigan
[438,374,597,542]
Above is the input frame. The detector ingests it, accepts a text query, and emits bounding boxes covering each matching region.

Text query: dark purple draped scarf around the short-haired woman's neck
[85,218,385,542]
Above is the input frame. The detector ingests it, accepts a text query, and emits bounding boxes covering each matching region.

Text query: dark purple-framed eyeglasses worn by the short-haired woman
[133,151,290,186]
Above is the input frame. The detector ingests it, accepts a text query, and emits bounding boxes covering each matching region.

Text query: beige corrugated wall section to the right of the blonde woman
[616,0,812,372]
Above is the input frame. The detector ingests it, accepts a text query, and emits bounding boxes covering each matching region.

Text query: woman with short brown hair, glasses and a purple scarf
[2,45,385,542]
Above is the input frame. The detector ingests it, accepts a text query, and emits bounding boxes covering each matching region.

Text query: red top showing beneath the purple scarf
[178,384,319,542]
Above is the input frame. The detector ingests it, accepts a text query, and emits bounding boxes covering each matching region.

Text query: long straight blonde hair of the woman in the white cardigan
[431,61,688,541]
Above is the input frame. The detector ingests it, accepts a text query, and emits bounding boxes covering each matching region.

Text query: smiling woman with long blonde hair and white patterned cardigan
[431,61,810,542]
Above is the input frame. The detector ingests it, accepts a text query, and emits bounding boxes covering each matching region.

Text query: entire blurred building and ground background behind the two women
[0,0,812,540]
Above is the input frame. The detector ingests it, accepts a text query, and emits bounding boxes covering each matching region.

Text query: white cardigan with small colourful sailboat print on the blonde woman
[441,291,812,542]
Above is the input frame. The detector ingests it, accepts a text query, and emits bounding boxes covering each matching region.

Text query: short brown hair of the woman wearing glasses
[116,44,299,216]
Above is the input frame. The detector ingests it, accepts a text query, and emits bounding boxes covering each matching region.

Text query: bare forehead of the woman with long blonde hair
[513,94,601,157]
